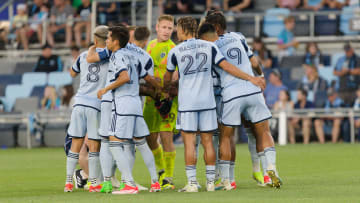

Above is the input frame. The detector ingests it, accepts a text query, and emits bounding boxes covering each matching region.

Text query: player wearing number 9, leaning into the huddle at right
[206,13,282,189]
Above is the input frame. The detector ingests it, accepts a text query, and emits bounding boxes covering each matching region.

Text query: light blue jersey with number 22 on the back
[167,39,225,112]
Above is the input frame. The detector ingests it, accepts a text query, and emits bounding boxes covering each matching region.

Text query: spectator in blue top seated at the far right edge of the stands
[334,43,360,105]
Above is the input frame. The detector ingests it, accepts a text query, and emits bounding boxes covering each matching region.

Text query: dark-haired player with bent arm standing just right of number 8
[98,27,160,194]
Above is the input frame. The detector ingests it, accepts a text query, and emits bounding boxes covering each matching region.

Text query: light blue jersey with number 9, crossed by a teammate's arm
[215,32,261,102]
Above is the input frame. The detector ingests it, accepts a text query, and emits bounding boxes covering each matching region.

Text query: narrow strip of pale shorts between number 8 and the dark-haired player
[99,101,113,137]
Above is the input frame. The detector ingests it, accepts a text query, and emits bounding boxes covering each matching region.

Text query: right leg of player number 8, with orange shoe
[86,108,102,192]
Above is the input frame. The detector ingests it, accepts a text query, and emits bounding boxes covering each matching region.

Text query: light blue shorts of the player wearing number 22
[176,109,218,132]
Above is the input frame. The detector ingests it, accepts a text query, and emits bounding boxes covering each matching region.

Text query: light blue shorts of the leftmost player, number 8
[68,105,101,140]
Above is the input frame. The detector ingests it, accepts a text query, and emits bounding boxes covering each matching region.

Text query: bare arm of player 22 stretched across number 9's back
[219,60,265,90]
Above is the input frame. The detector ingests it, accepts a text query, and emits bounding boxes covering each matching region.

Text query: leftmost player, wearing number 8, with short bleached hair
[64,26,108,192]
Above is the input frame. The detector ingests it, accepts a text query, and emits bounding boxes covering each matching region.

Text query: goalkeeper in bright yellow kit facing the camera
[144,15,178,189]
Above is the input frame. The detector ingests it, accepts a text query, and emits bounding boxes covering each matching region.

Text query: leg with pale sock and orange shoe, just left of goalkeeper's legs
[134,117,160,192]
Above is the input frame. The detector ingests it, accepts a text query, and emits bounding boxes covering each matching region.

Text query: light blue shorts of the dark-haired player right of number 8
[109,111,150,140]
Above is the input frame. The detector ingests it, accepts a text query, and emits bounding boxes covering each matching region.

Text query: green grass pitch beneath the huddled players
[0,144,360,203]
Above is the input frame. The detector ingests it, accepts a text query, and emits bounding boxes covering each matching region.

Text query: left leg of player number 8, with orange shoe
[64,106,86,192]
